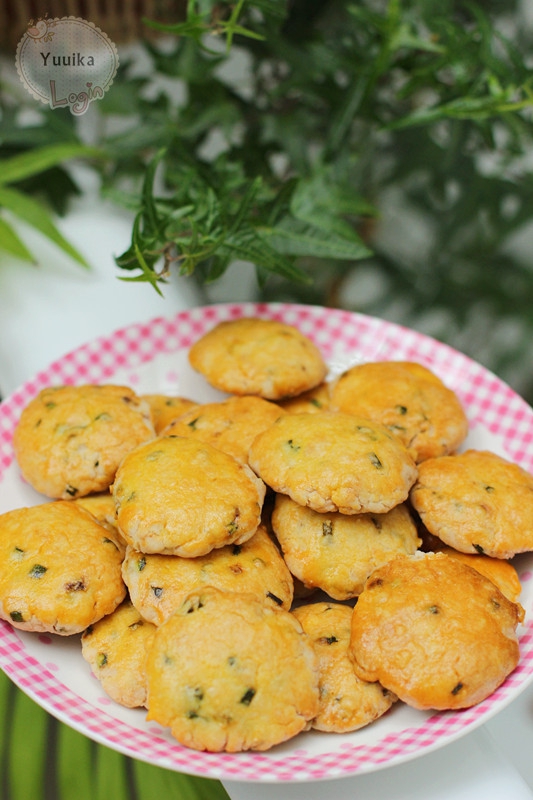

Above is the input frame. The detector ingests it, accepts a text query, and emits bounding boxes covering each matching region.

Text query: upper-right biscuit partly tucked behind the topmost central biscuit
[331,361,468,462]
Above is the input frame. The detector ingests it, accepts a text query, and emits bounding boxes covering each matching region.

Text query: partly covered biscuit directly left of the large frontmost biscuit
[81,599,156,708]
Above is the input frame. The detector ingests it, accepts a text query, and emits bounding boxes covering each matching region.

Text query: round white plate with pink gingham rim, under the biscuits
[0,303,533,782]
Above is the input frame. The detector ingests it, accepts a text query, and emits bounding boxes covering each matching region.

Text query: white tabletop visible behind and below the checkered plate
[0,181,533,800]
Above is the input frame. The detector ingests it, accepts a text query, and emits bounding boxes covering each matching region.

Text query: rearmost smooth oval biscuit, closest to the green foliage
[189,317,327,400]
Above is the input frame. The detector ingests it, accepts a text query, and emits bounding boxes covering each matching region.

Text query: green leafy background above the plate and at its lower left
[0,0,533,800]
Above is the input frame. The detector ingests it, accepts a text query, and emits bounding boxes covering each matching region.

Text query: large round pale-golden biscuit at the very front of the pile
[147,587,318,752]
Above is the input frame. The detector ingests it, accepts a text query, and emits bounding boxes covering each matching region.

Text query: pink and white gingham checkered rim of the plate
[0,303,533,782]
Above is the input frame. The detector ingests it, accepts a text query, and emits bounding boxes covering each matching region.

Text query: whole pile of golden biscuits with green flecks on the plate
[0,317,533,752]
